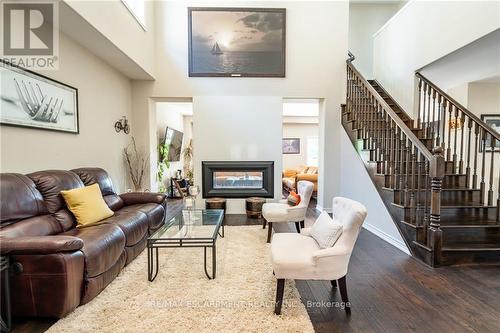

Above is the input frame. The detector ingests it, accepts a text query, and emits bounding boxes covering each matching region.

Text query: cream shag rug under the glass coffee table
[48,226,314,333]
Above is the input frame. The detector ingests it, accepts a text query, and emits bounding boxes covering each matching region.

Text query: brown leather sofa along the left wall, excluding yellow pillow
[0,168,166,318]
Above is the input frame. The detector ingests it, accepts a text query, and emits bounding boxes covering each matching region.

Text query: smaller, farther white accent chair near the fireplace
[262,180,314,243]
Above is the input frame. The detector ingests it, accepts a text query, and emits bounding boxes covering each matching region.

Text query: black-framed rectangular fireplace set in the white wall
[201,161,274,198]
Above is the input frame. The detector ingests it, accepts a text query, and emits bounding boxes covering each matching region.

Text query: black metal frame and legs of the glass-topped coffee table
[147,209,224,282]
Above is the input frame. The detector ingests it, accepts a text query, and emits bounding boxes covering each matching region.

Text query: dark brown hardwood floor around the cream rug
[8,200,500,333]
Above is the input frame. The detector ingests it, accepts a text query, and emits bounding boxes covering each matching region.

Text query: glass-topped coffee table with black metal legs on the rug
[147,209,224,281]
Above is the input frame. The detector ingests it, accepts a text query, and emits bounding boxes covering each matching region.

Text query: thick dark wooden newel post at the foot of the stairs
[429,146,445,267]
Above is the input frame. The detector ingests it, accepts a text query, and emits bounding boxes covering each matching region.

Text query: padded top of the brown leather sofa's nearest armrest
[0,236,83,254]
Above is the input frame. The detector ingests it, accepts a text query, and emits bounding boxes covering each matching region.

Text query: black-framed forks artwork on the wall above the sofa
[0,60,79,134]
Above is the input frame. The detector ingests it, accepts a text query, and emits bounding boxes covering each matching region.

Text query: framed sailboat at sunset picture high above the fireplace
[188,7,286,77]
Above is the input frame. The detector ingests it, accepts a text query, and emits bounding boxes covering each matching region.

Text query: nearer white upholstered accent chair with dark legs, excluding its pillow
[271,197,367,315]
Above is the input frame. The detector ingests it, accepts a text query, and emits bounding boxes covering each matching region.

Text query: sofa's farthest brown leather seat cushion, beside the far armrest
[106,209,148,246]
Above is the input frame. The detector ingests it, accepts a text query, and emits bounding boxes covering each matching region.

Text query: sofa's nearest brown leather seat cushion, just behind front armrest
[0,215,63,238]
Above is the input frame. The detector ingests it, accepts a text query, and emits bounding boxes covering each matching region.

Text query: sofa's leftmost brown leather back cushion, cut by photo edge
[0,173,47,224]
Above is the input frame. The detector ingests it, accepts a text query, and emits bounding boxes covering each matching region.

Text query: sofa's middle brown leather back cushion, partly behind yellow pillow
[27,170,83,213]
